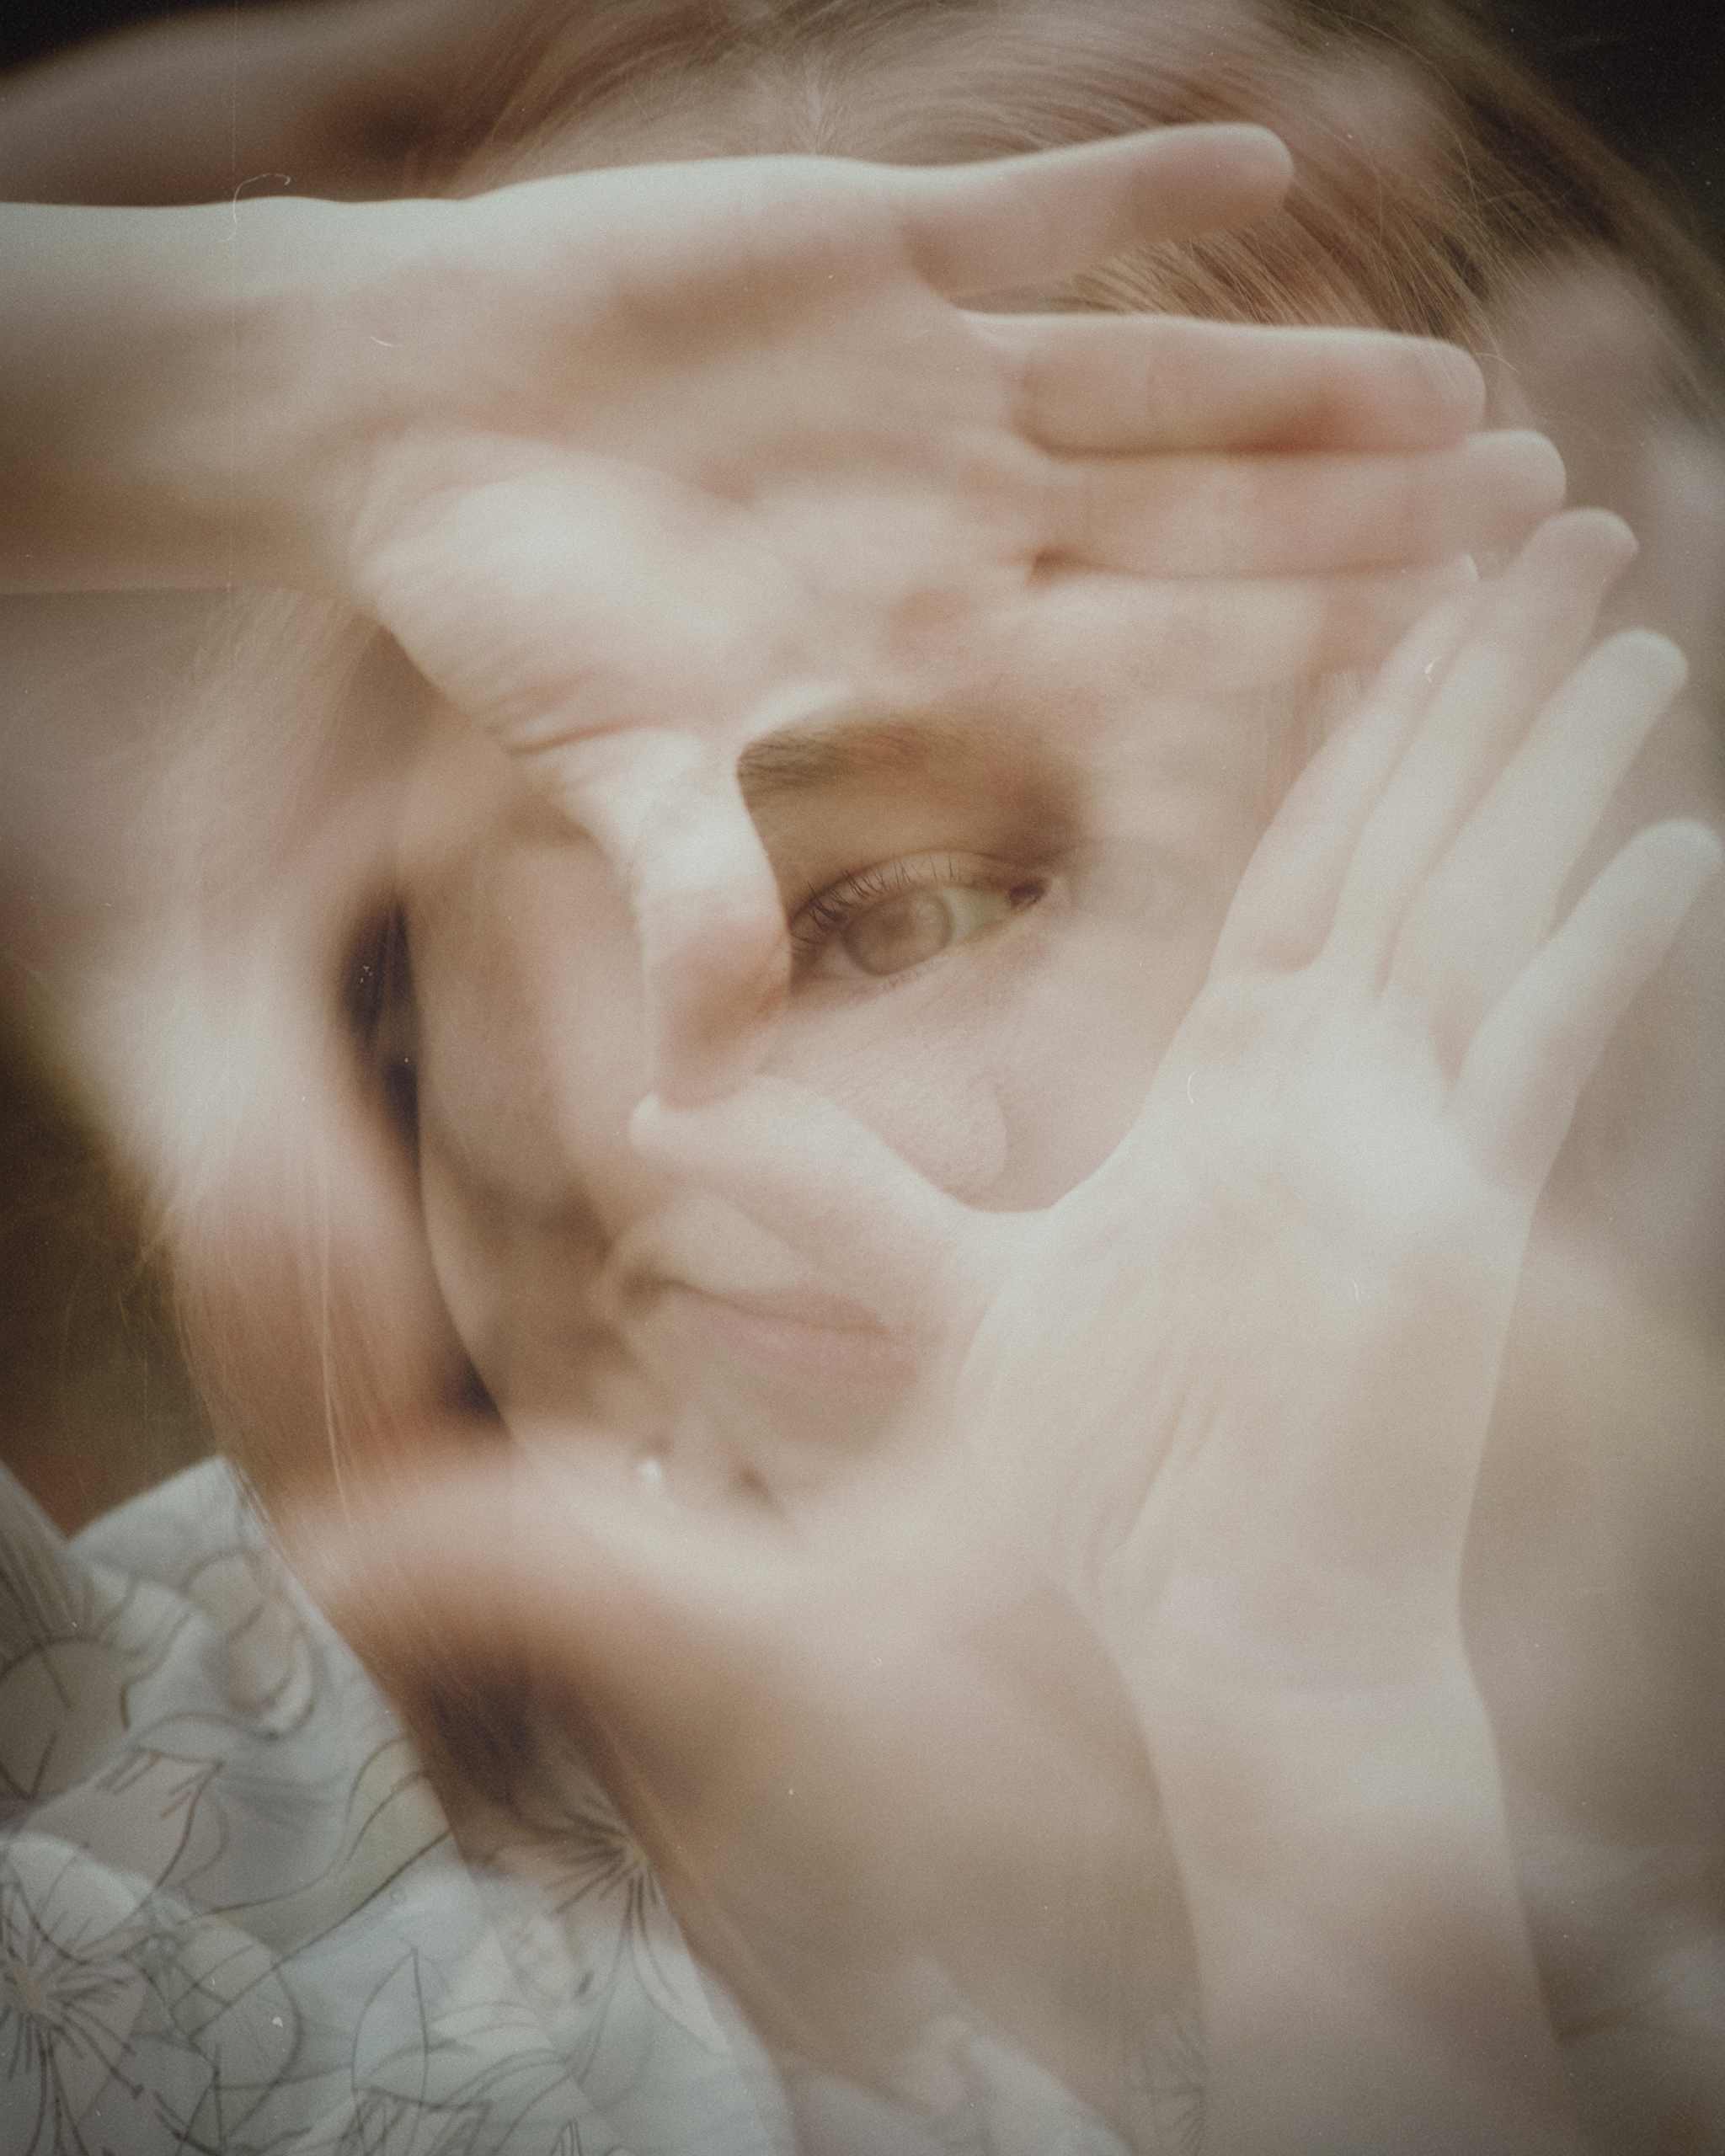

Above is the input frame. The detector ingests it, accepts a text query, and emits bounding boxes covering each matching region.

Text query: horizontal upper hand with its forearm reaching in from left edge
[0,127,1561,1097]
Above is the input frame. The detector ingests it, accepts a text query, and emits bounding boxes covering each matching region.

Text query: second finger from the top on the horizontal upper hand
[970,315,1486,453]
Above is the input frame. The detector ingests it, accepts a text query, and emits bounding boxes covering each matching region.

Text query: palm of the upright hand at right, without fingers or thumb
[970,973,1525,1646]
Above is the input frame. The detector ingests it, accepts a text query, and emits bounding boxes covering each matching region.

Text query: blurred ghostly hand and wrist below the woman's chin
[274,1438,1194,2112]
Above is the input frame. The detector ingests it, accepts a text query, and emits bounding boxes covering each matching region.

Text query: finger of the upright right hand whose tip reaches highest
[1326,509,1634,985]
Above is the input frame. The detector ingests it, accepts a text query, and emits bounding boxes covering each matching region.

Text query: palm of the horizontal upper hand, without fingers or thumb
[360,159,1046,750]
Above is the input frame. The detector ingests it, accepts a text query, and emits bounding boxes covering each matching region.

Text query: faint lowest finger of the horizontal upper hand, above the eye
[1022,561,1475,694]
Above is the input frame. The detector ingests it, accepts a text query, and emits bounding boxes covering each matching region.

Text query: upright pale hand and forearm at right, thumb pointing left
[638,515,1718,2149]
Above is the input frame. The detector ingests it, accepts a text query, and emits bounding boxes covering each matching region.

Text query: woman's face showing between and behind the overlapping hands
[408,679,1266,1501]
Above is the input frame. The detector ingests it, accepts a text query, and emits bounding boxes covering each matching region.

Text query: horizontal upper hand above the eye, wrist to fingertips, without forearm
[317,127,1561,1097]
